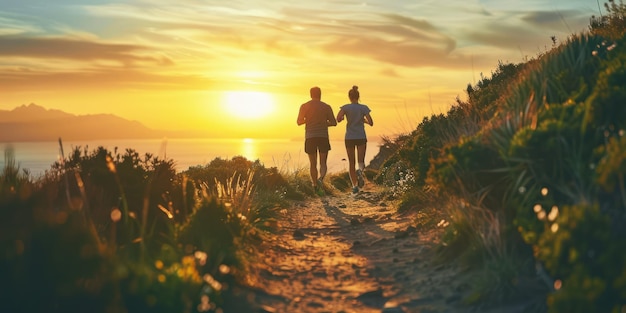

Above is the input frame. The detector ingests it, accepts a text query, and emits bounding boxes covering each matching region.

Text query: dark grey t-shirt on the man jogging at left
[298,100,335,138]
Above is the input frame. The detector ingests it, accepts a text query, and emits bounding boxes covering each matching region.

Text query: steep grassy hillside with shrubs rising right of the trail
[378,1,626,312]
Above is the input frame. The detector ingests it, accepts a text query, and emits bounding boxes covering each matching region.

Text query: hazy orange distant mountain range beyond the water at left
[0,103,199,142]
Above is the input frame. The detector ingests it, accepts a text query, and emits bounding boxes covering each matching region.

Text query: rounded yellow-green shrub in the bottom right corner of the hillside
[537,205,626,312]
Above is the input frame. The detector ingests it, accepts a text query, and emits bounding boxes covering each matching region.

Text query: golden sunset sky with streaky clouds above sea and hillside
[0,0,603,137]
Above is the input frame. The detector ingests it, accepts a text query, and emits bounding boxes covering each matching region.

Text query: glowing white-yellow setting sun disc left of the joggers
[224,91,274,119]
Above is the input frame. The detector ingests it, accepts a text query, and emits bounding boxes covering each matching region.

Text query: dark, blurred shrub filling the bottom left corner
[0,204,116,312]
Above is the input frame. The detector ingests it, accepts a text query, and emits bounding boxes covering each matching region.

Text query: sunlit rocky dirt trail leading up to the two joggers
[225,186,463,313]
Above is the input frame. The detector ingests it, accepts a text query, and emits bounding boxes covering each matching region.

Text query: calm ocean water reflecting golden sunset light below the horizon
[0,139,379,177]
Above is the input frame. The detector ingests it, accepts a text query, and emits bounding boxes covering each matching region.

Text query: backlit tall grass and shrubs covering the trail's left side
[0,141,286,312]
